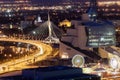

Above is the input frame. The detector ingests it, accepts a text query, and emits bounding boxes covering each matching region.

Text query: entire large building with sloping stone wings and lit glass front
[60,15,116,59]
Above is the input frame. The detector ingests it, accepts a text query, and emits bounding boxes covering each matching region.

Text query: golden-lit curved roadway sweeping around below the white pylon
[0,38,52,73]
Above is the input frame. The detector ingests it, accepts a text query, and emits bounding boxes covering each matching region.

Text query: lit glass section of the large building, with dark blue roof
[85,21,116,47]
